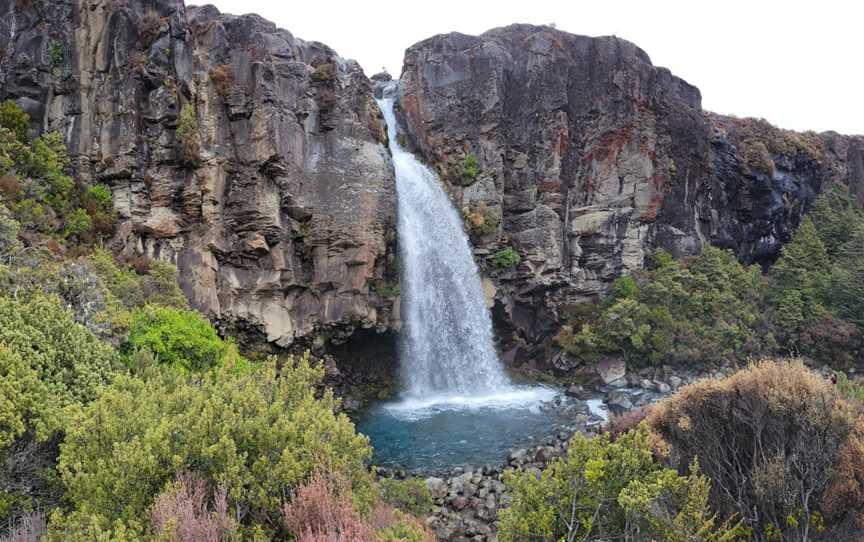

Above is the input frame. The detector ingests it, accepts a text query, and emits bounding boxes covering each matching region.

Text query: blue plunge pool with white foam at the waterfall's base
[355,386,606,473]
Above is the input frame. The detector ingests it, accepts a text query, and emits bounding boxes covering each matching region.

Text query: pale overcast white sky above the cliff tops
[199,0,864,134]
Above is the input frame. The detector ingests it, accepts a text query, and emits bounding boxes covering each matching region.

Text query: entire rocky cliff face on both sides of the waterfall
[0,4,864,366]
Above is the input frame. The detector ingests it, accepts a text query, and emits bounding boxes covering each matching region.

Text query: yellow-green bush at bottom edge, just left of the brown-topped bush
[499,424,743,542]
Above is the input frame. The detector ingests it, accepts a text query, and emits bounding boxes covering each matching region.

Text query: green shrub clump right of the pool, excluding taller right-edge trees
[556,247,775,365]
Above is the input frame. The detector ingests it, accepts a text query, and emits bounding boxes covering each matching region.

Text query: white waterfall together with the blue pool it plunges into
[357,83,572,471]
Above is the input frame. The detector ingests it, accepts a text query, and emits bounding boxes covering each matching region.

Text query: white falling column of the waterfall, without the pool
[378,85,510,399]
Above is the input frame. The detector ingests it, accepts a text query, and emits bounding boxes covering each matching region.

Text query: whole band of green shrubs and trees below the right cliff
[555,189,864,367]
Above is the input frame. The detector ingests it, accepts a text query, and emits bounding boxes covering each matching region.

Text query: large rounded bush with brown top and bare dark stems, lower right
[649,360,855,540]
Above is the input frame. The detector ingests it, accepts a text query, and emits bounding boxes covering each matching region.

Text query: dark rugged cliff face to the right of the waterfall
[400,25,864,366]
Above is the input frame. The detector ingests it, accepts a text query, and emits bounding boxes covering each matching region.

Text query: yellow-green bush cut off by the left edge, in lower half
[0,293,116,523]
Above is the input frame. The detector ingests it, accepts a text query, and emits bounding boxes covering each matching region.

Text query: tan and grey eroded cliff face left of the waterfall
[0,0,398,346]
